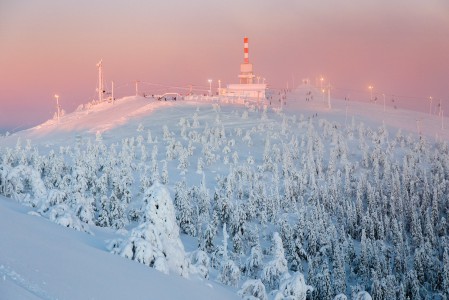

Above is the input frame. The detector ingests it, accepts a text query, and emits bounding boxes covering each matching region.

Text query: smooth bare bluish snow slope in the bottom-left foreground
[0,196,237,299]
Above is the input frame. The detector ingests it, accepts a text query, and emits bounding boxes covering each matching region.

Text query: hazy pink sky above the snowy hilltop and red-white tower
[0,0,449,128]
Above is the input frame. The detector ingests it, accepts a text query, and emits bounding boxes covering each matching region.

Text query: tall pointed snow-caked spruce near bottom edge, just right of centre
[261,232,288,290]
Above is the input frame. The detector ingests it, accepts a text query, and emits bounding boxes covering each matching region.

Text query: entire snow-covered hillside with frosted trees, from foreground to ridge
[0,86,449,299]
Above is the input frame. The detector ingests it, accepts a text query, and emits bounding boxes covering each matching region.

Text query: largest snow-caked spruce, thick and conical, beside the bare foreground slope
[112,182,188,277]
